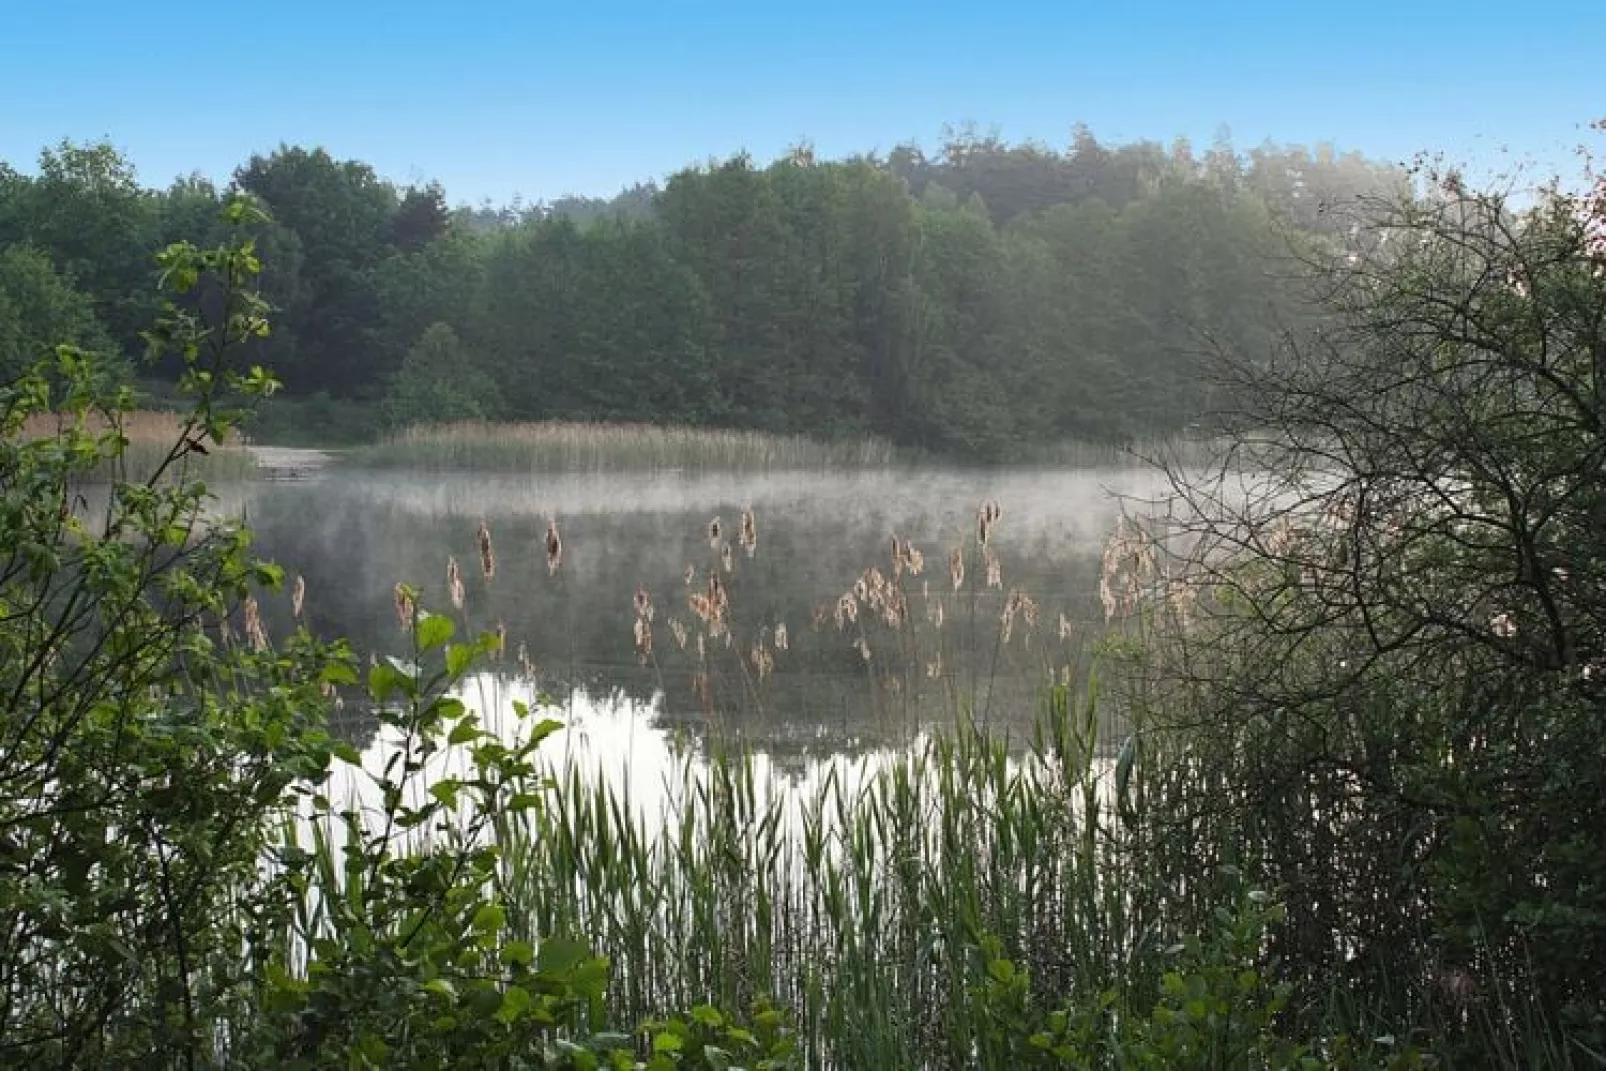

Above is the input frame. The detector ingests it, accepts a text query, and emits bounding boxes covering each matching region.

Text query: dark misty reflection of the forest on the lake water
[220,469,1161,754]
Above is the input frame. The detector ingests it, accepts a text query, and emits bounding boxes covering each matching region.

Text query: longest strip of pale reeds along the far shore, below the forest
[352,421,896,472]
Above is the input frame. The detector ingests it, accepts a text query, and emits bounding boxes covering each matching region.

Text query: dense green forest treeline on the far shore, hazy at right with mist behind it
[0,128,1402,458]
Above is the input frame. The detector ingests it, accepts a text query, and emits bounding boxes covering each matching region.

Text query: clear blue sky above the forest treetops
[0,0,1606,202]
